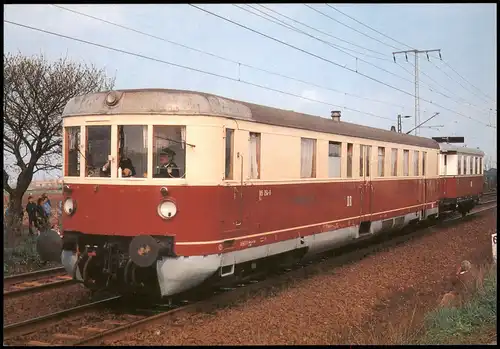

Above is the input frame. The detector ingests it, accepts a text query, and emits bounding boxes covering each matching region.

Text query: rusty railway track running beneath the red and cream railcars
[4,200,497,346]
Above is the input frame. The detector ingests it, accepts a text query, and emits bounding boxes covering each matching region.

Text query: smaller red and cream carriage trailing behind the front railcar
[439,143,484,215]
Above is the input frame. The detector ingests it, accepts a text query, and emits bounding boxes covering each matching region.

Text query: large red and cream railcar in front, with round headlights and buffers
[42,90,452,296]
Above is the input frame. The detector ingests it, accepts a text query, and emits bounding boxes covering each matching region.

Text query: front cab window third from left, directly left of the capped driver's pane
[117,125,148,178]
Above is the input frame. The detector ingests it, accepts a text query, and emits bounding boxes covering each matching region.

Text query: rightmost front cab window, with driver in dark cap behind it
[153,126,186,178]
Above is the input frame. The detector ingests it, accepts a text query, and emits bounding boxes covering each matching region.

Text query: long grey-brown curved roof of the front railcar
[63,89,439,149]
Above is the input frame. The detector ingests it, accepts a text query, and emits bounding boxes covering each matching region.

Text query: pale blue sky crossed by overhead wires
[4,4,497,179]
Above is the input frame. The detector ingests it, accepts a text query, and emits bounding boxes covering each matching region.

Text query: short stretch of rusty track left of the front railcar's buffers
[3,267,74,300]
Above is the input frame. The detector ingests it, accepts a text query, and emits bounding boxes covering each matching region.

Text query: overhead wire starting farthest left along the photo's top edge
[52,5,405,109]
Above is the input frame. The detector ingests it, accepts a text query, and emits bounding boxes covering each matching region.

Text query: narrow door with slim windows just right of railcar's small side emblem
[359,145,372,234]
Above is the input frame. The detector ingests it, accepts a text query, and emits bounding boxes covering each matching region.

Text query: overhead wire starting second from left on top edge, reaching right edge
[189,4,493,128]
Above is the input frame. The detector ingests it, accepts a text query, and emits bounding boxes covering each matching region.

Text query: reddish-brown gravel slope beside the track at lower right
[108,210,496,345]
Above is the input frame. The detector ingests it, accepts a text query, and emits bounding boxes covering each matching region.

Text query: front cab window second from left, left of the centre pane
[85,126,111,177]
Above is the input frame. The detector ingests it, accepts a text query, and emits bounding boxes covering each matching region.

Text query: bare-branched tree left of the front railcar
[3,53,114,240]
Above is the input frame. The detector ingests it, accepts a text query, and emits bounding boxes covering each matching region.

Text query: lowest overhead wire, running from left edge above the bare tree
[4,19,393,121]
